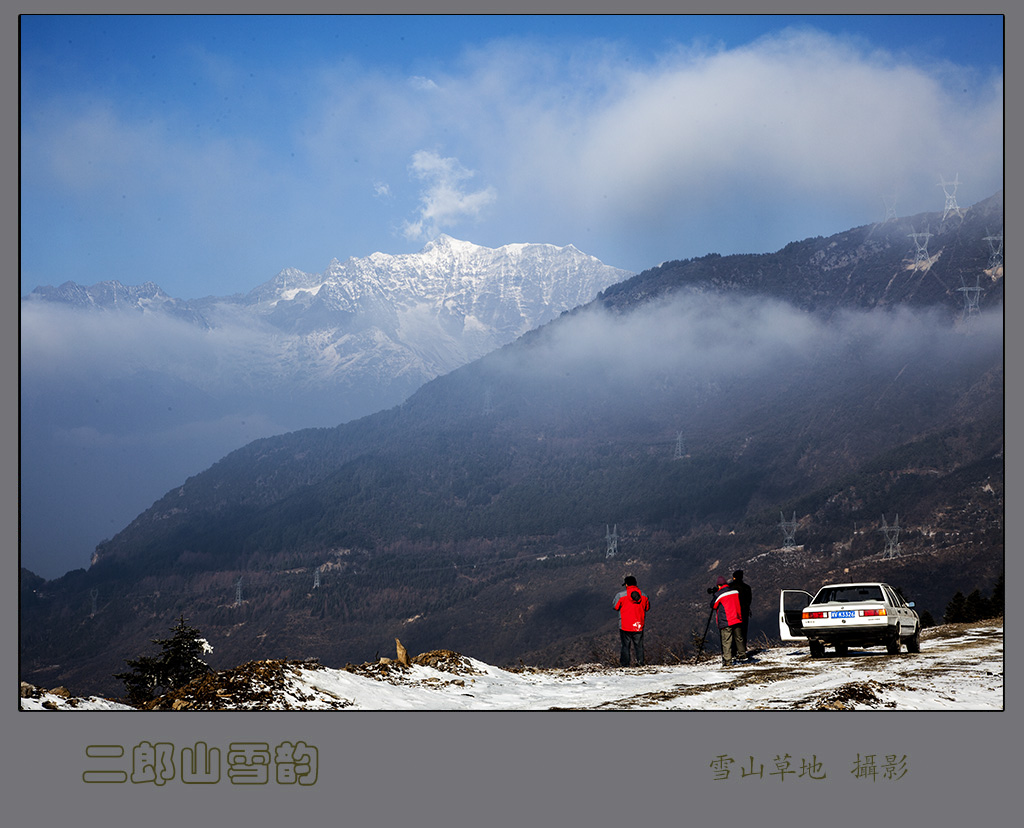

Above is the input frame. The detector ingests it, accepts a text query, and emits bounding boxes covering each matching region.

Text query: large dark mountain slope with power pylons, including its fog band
[22,193,1005,693]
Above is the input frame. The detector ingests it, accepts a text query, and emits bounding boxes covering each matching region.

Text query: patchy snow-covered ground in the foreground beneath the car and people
[22,622,1004,710]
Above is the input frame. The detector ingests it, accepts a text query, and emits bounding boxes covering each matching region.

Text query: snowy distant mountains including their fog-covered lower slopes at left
[22,235,631,574]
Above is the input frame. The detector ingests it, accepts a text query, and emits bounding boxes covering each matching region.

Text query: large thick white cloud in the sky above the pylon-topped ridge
[552,33,1001,222]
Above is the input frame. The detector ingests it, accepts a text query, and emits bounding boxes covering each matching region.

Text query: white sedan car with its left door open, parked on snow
[778,581,921,658]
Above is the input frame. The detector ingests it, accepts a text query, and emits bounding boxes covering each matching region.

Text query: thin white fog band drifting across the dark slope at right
[487,292,1002,404]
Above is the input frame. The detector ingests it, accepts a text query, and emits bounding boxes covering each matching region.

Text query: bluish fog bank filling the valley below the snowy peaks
[20,303,422,578]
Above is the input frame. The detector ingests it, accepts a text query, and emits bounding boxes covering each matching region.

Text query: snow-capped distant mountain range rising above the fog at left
[23,235,632,401]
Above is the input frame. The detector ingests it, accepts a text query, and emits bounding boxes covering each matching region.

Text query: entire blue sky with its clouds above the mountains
[20,14,1004,299]
